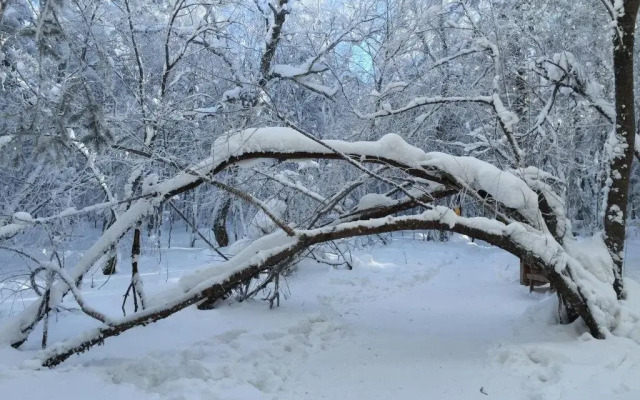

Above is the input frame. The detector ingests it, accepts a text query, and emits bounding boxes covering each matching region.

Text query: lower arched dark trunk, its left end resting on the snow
[37,207,604,367]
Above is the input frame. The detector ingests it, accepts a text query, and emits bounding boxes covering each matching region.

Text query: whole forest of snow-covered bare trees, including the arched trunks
[0,0,640,366]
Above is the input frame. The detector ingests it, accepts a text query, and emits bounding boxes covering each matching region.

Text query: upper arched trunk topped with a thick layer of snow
[0,127,584,344]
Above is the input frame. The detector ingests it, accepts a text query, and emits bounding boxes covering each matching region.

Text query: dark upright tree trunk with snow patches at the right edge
[604,0,640,299]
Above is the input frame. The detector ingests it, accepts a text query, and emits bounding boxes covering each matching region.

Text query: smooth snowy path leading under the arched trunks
[282,242,535,399]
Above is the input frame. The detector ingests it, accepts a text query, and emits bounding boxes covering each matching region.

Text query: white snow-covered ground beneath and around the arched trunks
[0,228,640,400]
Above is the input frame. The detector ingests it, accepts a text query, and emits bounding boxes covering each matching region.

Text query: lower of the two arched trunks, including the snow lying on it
[40,207,618,367]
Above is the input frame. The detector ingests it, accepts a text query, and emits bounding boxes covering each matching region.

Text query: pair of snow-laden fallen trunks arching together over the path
[0,128,617,366]
